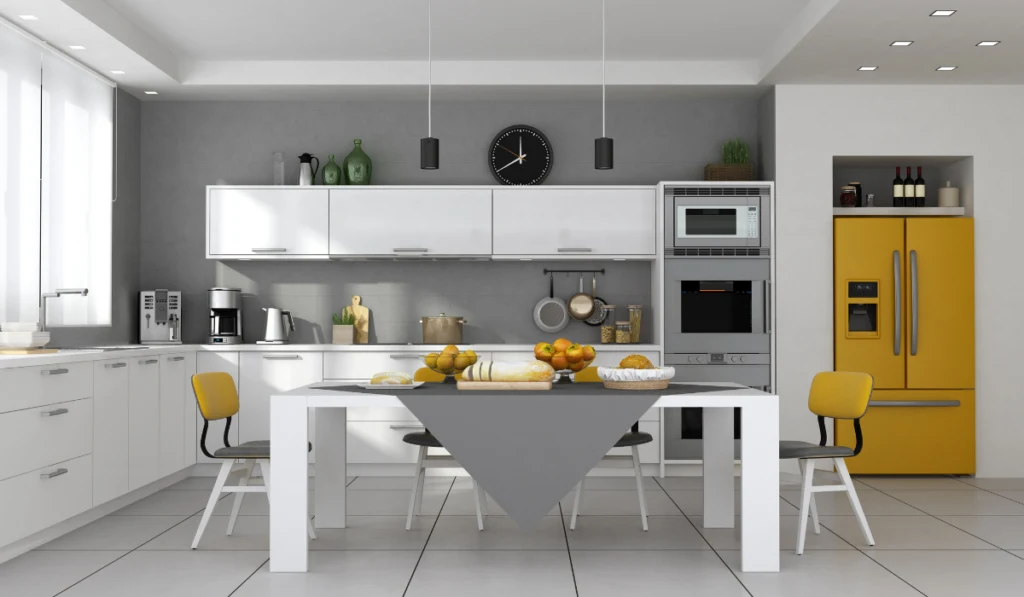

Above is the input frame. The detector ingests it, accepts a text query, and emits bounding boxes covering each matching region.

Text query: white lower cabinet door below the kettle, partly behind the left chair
[239,352,324,462]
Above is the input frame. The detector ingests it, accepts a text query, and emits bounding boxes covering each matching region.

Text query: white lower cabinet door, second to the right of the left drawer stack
[128,356,161,491]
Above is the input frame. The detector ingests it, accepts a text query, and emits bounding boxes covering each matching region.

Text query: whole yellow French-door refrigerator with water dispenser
[834,217,975,474]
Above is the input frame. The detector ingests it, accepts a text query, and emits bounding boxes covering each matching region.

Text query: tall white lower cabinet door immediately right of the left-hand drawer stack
[92,359,130,506]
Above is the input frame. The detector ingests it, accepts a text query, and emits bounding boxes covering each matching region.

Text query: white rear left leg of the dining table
[313,409,348,528]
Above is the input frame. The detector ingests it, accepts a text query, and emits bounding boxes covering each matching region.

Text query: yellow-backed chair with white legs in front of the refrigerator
[778,372,874,555]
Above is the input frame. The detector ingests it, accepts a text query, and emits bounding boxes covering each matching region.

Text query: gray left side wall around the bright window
[49,89,142,346]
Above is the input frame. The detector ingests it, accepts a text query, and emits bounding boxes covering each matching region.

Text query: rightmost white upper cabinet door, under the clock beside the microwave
[494,187,656,259]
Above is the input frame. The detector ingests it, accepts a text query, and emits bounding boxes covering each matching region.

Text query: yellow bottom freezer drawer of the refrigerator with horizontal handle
[836,390,975,475]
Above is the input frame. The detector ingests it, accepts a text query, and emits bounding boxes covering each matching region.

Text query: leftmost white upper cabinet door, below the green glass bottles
[207,186,329,259]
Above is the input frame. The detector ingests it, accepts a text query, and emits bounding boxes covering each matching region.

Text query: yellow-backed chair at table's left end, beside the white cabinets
[191,373,316,549]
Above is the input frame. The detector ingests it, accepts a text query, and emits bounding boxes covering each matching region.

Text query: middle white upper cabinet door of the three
[331,187,489,257]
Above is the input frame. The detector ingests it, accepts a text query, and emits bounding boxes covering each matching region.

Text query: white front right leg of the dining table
[741,399,779,572]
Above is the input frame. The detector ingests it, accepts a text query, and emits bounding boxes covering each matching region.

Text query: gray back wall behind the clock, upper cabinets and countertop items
[140,96,758,342]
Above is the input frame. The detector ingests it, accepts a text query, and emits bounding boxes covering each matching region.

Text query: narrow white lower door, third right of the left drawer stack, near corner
[159,354,188,477]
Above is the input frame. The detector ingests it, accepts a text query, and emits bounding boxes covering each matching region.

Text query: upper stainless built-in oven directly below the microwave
[665,257,771,354]
